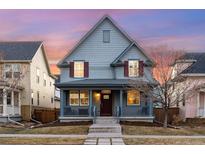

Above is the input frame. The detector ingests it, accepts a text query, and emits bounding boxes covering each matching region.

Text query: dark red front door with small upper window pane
[100,94,112,116]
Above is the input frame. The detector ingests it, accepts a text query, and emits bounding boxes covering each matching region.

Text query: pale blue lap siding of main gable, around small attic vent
[61,20,130,81]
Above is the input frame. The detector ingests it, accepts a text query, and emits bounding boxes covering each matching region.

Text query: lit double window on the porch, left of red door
[69,90,89,106]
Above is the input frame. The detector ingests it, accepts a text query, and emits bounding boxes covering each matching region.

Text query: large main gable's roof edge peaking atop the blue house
[57,15,153,66]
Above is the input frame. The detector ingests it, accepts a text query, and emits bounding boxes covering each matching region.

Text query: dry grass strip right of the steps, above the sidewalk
[122,125,205,135]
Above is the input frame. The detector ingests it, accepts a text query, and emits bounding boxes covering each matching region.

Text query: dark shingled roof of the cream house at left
[0,41,42,61]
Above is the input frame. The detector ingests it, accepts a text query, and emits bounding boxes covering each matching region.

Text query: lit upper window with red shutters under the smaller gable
[128,60,139,77]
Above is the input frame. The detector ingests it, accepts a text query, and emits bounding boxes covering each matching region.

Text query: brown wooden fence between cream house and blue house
[34,109,60,123]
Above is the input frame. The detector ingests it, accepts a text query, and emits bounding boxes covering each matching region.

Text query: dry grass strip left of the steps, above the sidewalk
[0,125,89,134]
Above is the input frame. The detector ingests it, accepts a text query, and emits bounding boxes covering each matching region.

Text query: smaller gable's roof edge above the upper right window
[111,42,155,65]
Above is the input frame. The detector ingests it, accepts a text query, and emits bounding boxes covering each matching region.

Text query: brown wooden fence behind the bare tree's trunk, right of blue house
[154,107,179,124]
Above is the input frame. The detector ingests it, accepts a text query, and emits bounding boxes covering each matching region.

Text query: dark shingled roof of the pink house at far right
[179,52,205,74]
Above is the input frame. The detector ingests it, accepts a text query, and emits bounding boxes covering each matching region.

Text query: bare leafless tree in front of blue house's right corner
[129,46,201,127]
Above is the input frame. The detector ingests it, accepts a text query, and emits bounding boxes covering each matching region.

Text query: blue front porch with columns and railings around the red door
[59,88,154,122]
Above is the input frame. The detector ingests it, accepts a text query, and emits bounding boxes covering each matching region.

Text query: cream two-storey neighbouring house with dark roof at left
[0,41,56,121]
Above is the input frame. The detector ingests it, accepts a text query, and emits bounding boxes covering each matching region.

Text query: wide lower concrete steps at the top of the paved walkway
[89,124,121,133]
